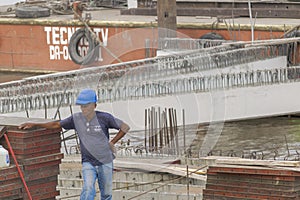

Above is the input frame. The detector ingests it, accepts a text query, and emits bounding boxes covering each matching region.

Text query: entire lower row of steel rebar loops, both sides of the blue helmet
[0,67,300,113]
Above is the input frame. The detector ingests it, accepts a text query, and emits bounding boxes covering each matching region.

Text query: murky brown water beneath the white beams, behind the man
[59,116,300,160]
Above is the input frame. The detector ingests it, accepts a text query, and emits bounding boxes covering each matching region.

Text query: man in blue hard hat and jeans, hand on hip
[19,89,129,200]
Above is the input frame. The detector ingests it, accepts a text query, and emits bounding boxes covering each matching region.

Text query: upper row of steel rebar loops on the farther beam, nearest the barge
[0,38,293,89]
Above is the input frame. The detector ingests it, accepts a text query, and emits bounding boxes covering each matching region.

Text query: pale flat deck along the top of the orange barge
[0,5,299,27]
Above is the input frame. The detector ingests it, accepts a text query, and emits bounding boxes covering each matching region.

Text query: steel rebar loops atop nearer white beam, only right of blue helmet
[98,67,300,102]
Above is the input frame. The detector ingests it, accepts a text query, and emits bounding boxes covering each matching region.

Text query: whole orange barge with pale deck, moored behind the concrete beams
[0,1,299,73]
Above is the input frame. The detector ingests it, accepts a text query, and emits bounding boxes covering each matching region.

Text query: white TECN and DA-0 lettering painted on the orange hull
[44,26,108,61]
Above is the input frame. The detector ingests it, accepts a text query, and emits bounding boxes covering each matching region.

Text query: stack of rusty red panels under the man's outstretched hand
[0,117,63,200]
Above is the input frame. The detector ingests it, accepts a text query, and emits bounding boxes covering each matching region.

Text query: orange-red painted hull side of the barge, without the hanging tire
[0,9,292,71]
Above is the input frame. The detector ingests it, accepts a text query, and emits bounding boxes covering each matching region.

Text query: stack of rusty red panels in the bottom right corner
[203,157,300,200]
